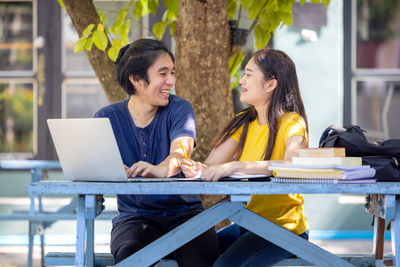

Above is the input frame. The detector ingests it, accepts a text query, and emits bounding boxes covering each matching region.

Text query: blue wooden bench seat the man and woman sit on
[44,252,382,267]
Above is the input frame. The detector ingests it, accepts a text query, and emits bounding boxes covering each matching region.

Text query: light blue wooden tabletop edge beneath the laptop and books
[27,181,400,195]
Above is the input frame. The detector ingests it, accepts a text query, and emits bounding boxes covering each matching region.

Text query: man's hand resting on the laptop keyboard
[124,161,168,178]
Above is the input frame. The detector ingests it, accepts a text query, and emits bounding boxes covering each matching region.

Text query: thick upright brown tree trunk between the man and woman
[175,0,233,161]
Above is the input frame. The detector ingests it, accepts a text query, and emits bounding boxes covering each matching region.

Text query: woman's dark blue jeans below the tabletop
[213,224,308,267]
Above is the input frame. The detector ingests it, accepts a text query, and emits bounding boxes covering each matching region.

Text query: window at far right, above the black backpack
[351,0,400,141]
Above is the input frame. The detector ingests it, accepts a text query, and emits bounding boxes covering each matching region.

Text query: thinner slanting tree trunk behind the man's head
[64,0,127,103]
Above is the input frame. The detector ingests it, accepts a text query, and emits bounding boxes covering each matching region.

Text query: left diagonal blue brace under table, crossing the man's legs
[115,201,244,267]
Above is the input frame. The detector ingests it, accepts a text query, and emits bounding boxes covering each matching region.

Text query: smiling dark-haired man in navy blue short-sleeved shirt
[95,39,218,266]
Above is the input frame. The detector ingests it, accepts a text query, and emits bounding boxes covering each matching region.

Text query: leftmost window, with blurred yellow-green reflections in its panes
[0,1,37,158]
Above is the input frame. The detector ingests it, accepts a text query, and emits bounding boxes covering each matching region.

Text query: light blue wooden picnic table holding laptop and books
[27,180,400,267]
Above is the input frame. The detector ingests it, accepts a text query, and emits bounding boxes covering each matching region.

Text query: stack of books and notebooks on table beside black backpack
[269,147,375,183]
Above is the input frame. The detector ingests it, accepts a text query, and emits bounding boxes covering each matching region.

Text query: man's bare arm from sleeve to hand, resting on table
[125,136,194,178]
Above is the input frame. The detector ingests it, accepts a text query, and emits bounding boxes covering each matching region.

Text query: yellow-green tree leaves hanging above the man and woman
[63,0,330,88]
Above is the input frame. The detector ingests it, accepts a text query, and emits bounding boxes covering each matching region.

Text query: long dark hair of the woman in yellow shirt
[213,48,308,160]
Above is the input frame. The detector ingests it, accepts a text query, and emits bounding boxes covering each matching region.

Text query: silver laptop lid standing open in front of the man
[47,118,128,182]
